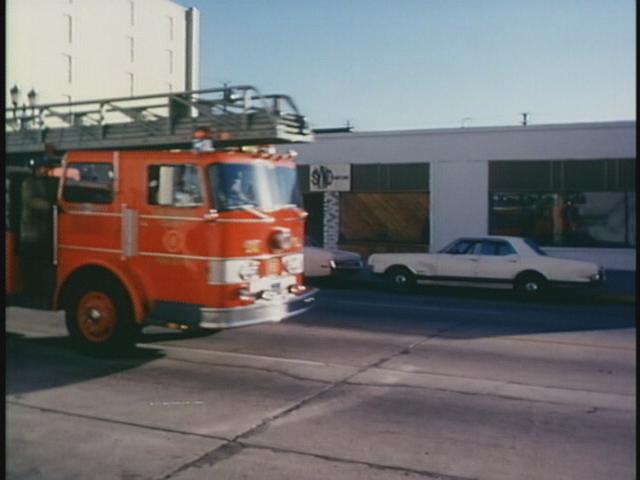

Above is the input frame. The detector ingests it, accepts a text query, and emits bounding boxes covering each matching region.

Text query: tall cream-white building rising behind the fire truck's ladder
[5,0,199,108]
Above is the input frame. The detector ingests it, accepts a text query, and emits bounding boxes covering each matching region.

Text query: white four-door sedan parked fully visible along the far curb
[368,236,604,293]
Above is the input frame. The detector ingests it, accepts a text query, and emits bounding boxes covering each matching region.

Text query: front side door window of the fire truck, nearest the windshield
[148,165,202,207]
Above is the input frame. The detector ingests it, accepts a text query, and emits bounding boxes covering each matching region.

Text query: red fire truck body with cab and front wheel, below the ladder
[6,143,314,352]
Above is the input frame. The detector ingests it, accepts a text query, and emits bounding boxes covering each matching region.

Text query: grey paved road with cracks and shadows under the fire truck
[6,289,636,480]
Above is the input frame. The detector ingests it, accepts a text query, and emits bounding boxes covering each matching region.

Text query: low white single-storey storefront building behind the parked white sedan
[296,121,636,270]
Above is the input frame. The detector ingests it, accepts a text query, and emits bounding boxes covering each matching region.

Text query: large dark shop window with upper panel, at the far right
[489,159,636,247]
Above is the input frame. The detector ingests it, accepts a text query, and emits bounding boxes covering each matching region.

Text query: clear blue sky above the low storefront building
[179,0,636,131]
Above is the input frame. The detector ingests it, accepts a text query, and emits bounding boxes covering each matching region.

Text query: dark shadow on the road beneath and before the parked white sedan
[292,278,636,339]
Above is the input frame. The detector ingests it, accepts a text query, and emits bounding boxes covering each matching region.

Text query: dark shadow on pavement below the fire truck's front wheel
[5,333,164,395]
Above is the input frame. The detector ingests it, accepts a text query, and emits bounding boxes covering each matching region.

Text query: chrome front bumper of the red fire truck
[199,289,318,329]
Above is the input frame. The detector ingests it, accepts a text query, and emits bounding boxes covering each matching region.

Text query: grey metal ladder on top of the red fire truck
[5,85,313,154]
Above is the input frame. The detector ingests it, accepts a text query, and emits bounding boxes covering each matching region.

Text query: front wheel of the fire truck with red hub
[65,277,140,354]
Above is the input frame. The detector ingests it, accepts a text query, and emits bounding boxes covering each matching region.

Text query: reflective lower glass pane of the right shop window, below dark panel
[490,192,635,247]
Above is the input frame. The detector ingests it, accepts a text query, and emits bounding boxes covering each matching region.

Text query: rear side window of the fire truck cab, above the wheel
[62,163,114,203]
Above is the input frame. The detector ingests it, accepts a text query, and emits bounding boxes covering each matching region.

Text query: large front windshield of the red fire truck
[208,163,301,211]
